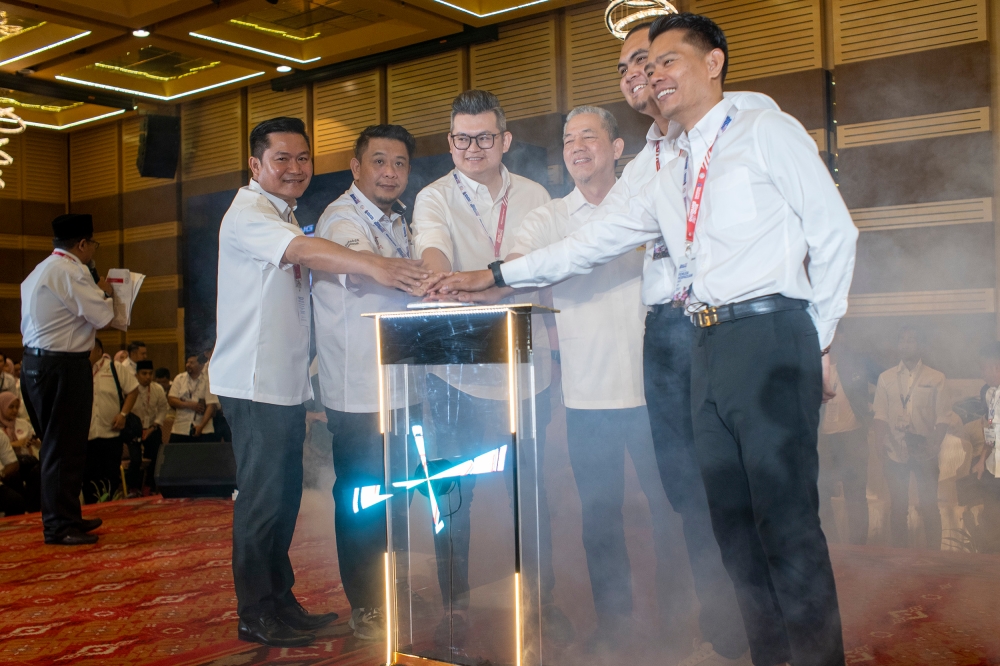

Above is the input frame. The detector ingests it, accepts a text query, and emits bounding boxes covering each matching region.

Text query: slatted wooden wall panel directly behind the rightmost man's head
[691,0,823,82]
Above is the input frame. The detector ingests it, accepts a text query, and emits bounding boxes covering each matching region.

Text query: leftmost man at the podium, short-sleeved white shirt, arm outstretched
[210,117,428,647]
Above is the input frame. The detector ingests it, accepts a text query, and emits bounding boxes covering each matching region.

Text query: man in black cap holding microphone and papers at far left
[21,214,114,545]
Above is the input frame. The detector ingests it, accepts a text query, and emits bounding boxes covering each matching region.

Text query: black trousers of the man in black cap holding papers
[21,354,94,538]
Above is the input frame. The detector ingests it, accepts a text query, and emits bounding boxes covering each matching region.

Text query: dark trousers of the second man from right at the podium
[643,306,747,659]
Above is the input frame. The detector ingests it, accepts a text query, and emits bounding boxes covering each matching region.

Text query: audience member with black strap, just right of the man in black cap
[83,338,139,504]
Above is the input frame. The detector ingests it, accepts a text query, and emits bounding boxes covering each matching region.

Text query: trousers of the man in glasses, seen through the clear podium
[427,375,555,611]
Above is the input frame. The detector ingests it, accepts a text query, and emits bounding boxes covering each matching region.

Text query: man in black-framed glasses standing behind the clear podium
[413,90,566,647]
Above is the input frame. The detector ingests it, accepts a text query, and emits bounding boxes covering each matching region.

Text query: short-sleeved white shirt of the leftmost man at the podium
[207,180,312,404]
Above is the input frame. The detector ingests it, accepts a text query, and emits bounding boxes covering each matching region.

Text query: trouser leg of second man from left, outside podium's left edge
[326,409,386,609]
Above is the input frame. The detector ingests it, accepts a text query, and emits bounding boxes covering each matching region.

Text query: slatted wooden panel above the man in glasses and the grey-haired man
[469,16,558,120]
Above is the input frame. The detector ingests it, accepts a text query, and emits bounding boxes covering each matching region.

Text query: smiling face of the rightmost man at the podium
[646,28,726,130]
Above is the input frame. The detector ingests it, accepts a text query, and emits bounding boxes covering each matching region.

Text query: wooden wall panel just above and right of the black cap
[69,123,119,201]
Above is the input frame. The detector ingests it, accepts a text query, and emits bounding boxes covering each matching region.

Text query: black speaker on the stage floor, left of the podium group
[153,442,236,497]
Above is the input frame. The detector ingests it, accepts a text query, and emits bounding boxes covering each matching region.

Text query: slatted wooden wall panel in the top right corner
[833,0,987,65]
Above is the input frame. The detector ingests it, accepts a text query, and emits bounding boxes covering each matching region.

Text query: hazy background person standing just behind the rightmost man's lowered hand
[818,334,871,546]
